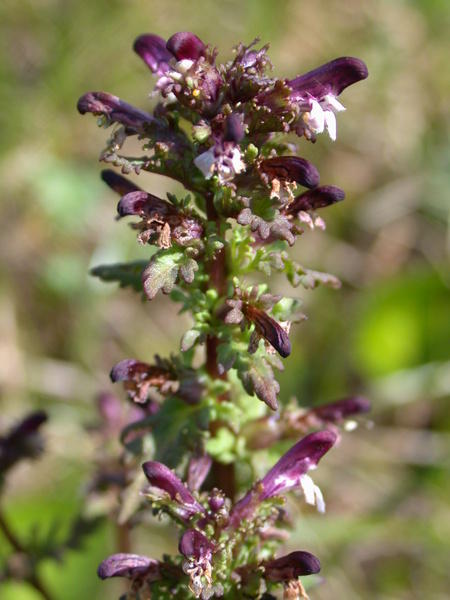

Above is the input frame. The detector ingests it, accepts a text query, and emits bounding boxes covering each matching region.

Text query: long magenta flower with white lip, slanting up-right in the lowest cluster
[230,430,337,527]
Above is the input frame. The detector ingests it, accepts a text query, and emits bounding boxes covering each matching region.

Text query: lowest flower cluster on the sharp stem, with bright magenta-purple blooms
[98,431,336,600]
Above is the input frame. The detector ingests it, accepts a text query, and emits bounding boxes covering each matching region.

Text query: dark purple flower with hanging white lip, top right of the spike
[286,57,368,140]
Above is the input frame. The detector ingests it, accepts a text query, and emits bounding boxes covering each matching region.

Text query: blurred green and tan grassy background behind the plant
[0,0,450,600]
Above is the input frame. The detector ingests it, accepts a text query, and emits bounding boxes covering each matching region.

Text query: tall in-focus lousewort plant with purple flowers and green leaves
[78,32,369,599]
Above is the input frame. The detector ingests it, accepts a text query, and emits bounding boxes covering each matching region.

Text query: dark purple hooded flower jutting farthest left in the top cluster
[77,92,154,133]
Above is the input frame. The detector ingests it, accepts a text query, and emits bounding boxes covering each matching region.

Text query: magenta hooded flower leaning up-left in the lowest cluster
[142,461,204,521]
